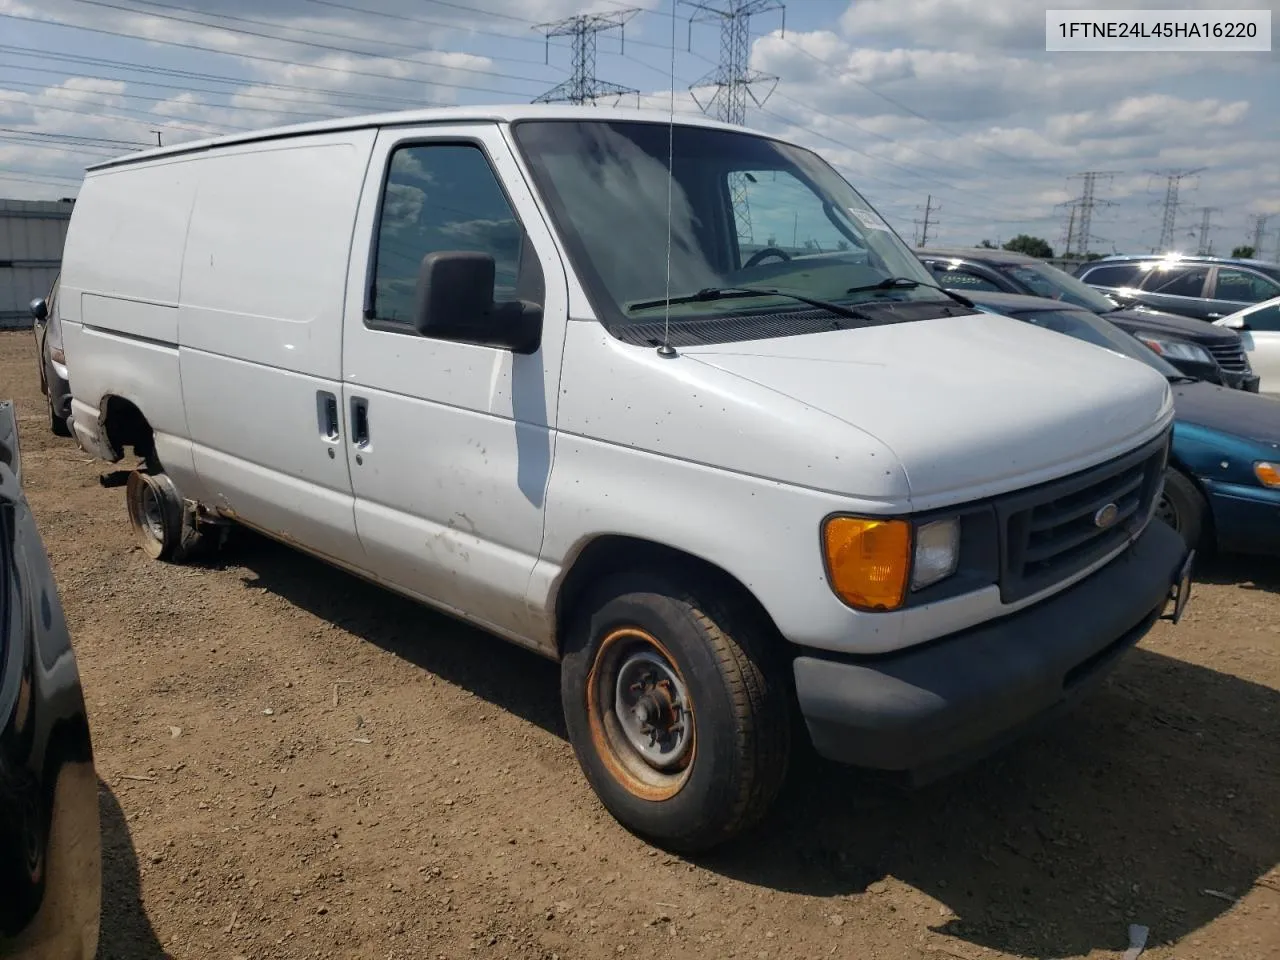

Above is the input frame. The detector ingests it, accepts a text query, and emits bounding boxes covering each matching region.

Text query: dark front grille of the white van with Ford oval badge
[996,433,1169,603]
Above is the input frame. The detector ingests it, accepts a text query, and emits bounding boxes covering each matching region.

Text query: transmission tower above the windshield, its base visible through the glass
[680,0,787,243]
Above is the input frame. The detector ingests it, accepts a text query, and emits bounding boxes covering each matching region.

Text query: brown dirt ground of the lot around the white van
[0,333,1280,960]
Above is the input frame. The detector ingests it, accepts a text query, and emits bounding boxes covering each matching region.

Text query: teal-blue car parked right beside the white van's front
[965,292,1280,556]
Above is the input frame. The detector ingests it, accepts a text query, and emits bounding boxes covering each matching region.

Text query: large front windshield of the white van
[513,120,955,324]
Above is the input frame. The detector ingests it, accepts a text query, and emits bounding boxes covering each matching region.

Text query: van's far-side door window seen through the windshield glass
[727,170,858,266]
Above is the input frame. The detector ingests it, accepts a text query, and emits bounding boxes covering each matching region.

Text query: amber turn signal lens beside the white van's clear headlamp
[822,517,911,611]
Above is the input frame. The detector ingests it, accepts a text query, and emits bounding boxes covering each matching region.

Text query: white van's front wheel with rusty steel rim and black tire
[561,572,791,852]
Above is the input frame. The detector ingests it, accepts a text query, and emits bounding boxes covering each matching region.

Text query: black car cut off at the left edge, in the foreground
[0,401,101,960]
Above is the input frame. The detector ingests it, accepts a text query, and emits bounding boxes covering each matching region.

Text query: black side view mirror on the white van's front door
[413,251,543,353]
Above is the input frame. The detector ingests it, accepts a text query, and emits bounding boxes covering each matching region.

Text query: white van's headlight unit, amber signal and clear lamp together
[822,517,960,611]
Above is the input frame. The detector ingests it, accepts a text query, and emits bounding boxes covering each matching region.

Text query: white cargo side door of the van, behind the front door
[178,131,375,566]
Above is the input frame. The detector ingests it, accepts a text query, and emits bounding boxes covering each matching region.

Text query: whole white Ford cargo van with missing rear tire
[60,106,1188,849]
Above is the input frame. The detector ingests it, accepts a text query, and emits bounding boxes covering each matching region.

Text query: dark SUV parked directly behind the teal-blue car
[915,247,1258,392]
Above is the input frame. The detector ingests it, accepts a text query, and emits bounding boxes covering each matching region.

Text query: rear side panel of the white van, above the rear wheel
[59,160,201,497]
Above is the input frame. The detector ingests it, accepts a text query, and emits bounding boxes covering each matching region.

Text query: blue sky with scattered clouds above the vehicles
[0,0,1280,259]
